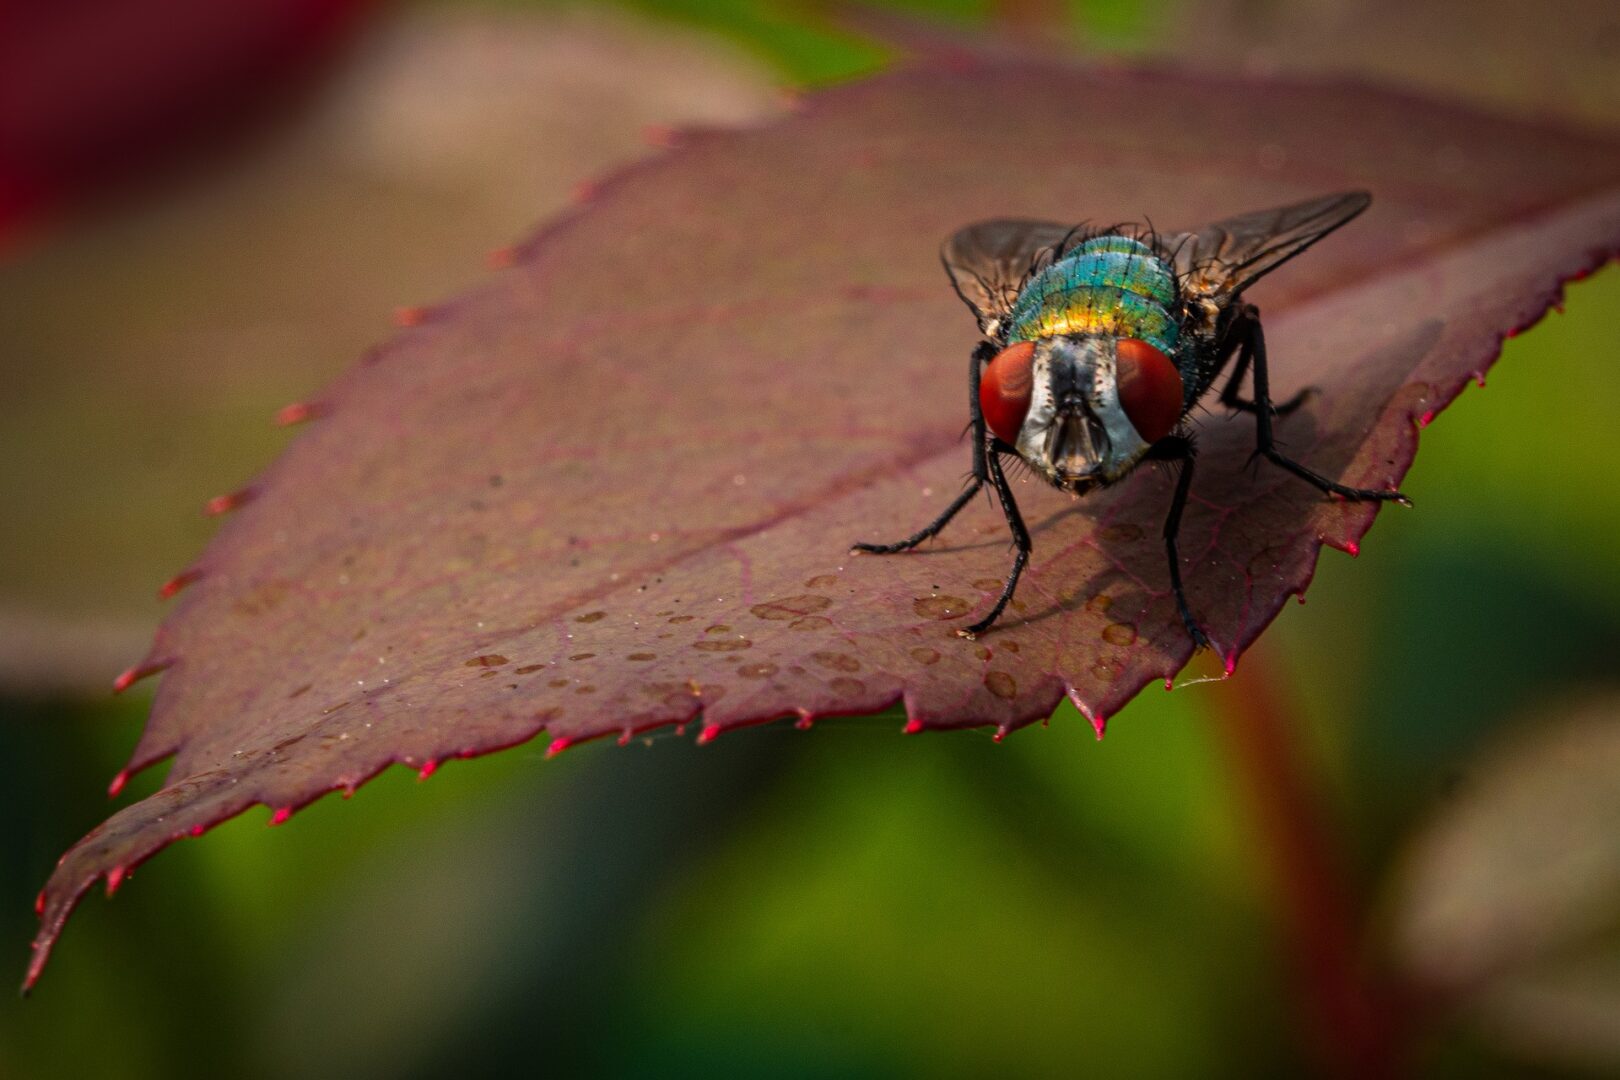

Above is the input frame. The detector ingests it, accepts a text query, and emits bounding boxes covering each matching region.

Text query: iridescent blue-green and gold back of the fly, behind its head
[1008,236,1181,355]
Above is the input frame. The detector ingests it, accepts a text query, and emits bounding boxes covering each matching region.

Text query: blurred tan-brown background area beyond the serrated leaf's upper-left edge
[0,5,776,695]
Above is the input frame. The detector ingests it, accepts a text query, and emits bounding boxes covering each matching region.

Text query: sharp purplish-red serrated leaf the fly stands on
[29,55,1620,980]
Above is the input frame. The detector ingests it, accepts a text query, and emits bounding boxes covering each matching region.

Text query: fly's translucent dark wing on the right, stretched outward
[1158,191,1372,304]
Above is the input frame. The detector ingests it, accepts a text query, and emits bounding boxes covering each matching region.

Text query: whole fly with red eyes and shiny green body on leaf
[855,191,1411,646]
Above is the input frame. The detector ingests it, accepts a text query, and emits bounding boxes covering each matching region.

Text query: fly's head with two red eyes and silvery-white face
[978,335,1183,495]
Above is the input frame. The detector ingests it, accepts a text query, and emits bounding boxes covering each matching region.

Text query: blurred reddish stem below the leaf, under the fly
[1215,648,1406,1078]
